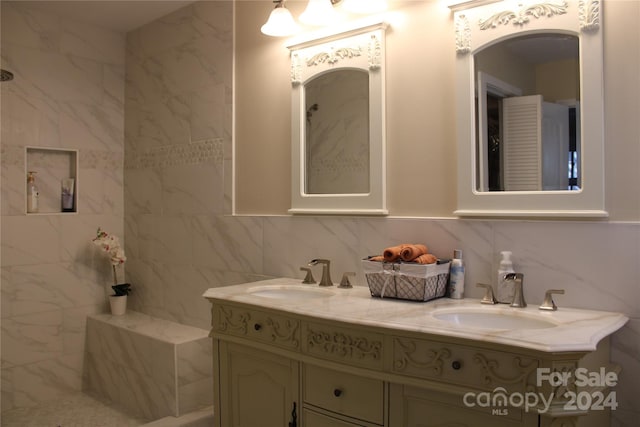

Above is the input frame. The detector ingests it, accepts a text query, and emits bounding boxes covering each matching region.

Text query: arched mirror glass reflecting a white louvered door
[474,33,583,192]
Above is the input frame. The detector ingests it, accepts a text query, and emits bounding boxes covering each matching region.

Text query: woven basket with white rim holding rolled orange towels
[362,259,449,301]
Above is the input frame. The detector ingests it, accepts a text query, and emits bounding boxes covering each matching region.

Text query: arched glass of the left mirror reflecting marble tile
[304,69,370,194]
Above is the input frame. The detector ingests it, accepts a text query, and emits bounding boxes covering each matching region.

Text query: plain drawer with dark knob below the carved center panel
[303,365,384,424]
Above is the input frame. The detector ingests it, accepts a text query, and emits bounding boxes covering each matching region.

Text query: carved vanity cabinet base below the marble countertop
[205,294,610,427]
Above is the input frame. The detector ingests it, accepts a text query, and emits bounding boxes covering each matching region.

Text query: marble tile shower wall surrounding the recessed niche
[1,1,125,410]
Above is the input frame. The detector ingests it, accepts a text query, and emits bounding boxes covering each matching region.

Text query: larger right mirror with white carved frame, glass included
[454,0,607,217]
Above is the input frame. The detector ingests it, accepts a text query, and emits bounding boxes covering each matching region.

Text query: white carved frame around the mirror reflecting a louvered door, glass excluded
[454,0,608,217]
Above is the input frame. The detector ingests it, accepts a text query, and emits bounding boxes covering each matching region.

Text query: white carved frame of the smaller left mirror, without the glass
[287,22,389,215]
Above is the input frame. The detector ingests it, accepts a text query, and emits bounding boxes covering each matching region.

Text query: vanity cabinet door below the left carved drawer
[219,342,300,427]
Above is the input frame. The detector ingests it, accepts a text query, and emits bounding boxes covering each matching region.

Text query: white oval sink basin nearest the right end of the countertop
[433,309,557,329]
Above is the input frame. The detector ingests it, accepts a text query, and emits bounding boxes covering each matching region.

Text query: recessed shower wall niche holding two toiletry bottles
[24,147,78,215]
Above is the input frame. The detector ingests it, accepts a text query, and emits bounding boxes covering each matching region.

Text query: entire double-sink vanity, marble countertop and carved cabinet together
[204,278,627,427]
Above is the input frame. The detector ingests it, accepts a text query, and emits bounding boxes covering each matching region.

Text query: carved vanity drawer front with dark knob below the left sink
[211,305,300,350]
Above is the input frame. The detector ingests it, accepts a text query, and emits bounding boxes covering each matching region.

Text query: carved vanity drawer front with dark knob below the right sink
[392,337,540,392]
